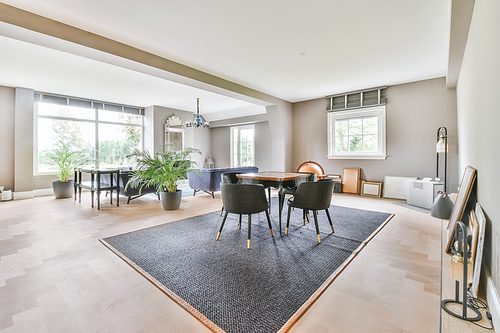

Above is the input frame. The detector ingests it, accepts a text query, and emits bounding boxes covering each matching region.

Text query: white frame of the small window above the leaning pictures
[327,105,387,160]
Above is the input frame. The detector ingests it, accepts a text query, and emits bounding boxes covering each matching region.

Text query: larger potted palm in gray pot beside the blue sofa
[126,147,201,210]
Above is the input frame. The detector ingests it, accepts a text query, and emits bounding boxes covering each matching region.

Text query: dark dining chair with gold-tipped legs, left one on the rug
[217,183,274,248]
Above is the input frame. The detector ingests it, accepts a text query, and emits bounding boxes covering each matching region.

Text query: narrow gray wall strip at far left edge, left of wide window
[0,86,15,190]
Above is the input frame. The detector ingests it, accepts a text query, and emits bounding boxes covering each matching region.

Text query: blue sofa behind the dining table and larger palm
[188,167,259,197]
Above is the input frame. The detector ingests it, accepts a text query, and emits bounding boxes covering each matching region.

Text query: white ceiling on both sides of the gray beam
[0,0,450,120]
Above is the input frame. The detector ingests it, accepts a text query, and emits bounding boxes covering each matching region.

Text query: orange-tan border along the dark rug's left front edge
[99,238,225,333]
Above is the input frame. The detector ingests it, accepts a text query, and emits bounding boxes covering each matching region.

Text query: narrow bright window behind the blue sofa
[231,125,255,167]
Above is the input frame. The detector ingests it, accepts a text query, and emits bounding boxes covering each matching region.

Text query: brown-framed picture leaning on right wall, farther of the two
[445,166,477,253]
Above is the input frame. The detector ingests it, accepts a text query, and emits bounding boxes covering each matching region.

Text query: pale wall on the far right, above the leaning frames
[457,0,500,304]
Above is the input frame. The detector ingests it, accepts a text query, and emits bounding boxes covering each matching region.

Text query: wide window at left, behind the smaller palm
[34,98,143,174]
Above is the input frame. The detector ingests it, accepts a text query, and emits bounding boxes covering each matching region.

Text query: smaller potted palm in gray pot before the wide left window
[47,142,94,199]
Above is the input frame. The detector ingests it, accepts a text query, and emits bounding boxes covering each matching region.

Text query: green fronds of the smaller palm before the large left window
[47,142,94,182]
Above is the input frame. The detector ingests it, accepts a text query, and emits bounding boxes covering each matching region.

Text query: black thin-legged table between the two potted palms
[75,168,120,210]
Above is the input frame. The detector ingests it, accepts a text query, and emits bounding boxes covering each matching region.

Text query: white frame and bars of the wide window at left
[33,101,144,176]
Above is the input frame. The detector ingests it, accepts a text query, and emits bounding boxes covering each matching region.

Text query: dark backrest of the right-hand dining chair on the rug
[291,179,333,210]
